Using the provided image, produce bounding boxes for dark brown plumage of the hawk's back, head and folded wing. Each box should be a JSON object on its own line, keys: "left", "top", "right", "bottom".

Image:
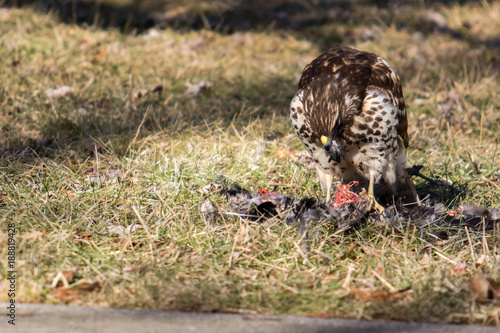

{"left": 298, "top": 47, "right": 408, "bottom": 147}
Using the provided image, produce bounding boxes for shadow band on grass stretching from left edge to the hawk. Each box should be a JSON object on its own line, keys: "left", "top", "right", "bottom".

{"left": 0, "top": 71, "right": 296, "bottom": 164}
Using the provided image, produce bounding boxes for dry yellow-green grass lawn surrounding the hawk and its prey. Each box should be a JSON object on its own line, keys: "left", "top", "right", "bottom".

{"left": 0, "top": 1, "right": 500, "bottom": 325}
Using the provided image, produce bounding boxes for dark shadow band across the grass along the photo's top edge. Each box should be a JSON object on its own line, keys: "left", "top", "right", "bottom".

{"left": 4, "top": 0, "right": 500, "bottom": 50}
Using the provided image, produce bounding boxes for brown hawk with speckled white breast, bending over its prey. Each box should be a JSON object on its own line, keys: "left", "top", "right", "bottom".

{"left": 290, "top": 47, "right": 420, "bottom": 210}
